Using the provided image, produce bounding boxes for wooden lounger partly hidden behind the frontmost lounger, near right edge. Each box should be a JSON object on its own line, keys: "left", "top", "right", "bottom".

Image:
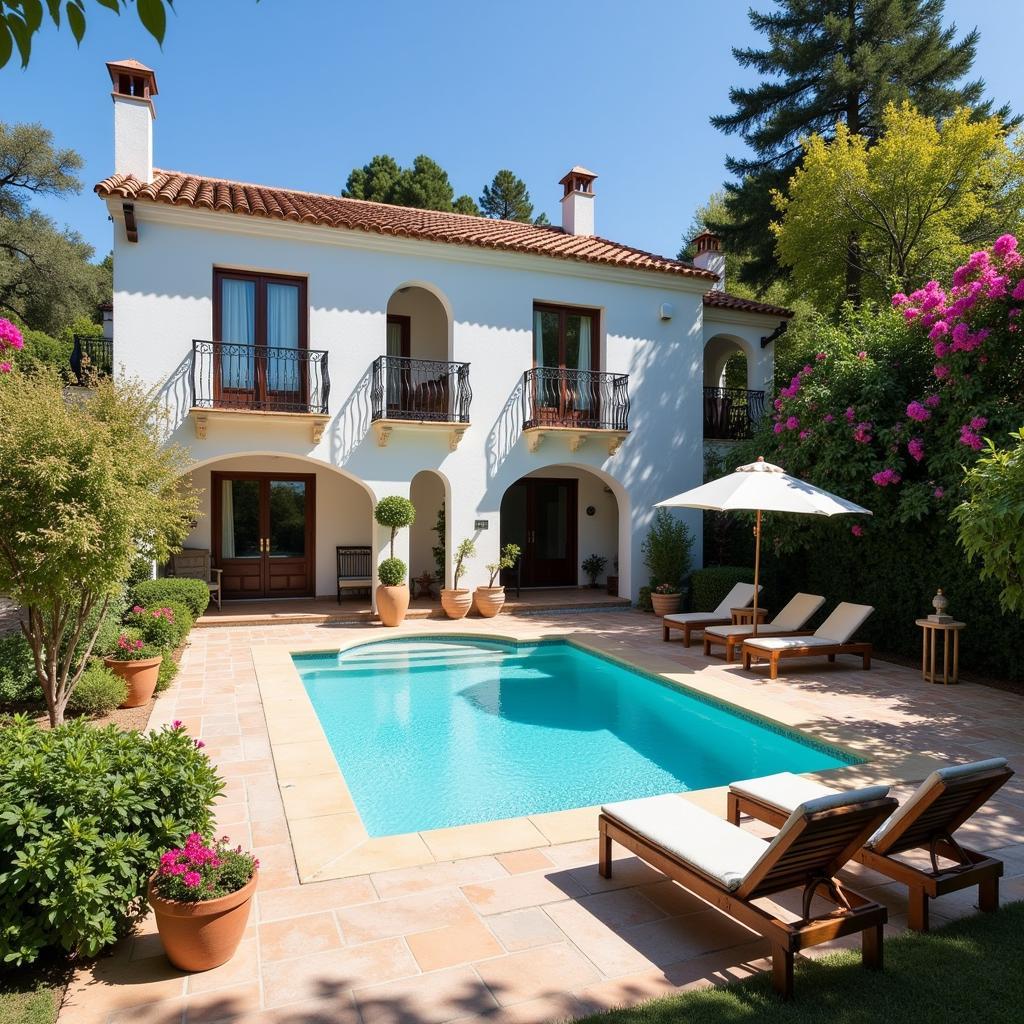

{"left": 726, "top": 758, "right": 1014, "bottom": 932}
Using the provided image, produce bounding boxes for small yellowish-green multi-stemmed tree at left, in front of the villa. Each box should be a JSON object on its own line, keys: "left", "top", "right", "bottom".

{"left": 0, "top": 368, "right": 199, "bottom": 725}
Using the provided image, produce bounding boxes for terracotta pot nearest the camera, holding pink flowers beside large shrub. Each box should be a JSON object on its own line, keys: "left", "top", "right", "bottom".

{"left": 146, "top": 869, "right": 259, "bottom": 971}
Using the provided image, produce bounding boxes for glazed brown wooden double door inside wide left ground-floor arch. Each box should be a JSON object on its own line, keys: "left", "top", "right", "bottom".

{"left": 210, "top": 472, "right": 316, "bottom": 599}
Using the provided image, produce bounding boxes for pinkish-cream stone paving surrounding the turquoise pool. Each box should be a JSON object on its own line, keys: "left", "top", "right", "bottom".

{"left": 60, "top": 611, "right": 1024, "bottom": 1024}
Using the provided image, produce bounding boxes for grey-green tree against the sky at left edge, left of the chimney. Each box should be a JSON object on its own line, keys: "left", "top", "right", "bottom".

{"left": 0, "top": 123, "right": 112, "bottom": 335}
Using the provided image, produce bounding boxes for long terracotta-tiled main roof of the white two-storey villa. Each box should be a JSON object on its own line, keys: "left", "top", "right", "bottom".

{"left": 95, "top": 170, "right": 715, "bottom": 281}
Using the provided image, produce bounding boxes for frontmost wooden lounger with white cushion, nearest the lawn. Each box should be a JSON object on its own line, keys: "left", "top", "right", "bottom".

{"left": 598, "top": 786, "right": 896, "bottom": 997}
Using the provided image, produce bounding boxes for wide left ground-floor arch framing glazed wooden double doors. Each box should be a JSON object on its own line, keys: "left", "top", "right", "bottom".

{"left": 184, "top": 453, "right": 375, "bottom": 608}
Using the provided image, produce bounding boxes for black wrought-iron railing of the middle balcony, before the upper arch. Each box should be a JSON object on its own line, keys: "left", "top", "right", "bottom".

{"left": 370, "top": 355, "right": 473, "bottom": 423}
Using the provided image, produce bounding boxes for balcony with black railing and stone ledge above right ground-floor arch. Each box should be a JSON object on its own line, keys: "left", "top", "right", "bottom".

{"left": 522, "top": 367, "right": 630, "bottom": 455}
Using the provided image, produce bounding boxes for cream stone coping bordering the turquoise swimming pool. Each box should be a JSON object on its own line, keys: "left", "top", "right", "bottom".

{"left": 251, "top": 623, "right": 944, "bottom": 883}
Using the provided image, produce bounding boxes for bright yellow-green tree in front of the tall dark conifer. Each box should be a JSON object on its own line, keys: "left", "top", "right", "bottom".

{"left": 772, "top": 103, "right": 1024, "bottom": 308}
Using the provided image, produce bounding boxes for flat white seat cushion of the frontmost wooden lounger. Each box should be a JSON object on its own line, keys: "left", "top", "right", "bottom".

{"left": 601, "top": 795, "right": 768, "bottom": 892}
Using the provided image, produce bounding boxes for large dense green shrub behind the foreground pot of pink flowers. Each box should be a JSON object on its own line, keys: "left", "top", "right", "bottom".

{"left": 0, "top": 716, "right": 223, "bottom": 968}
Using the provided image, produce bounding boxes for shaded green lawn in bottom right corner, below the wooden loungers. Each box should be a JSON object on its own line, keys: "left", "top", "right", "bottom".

{"left": 587, "top": 903, "right": 1024, "bottom": 1024}
